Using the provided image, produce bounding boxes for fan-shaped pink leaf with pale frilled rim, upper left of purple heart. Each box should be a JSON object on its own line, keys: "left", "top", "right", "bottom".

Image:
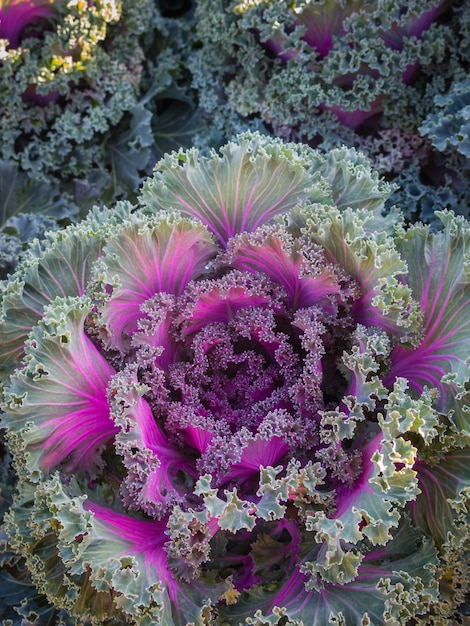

{"left": 93, "top": 215, "right": 215, "bottom": 350}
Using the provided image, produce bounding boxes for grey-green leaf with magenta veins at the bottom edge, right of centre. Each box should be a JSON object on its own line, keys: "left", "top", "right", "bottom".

{"left": 221, "top": 523, "right": 437, "bottom": 626}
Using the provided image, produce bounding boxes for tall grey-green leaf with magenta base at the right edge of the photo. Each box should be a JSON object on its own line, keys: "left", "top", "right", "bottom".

{"left": 385, "top": 213, "right": 470, "bottom": 440}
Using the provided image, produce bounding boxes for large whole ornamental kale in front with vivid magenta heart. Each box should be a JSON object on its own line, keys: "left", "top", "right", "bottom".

{"left": 0, "top": 133, "right": 470, "bottom": 626}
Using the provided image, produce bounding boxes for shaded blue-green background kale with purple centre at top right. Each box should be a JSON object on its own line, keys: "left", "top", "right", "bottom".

{"left": 189, "top": 0, "right": 470, "bottom": 223}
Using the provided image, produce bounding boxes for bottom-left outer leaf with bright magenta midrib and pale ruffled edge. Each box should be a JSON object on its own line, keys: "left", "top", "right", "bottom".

{"left": 82, "top": 502, "right": 226, "bottom": 626}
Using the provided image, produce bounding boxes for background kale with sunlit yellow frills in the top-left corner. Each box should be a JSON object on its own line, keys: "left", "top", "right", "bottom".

{"left": 0, "top": 0, "right": 202, "bottom": 212}
